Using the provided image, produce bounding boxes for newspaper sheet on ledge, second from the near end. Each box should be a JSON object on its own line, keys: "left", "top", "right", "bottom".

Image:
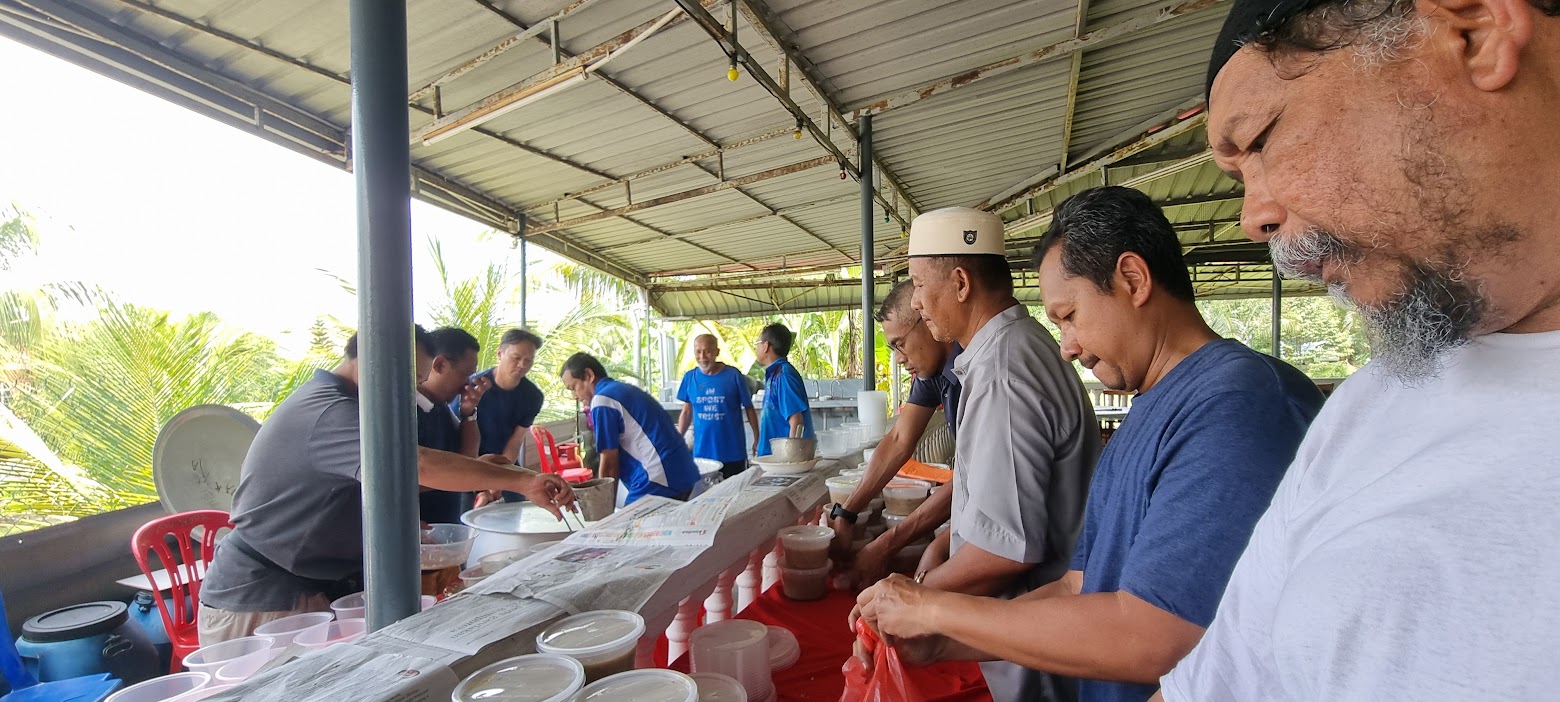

{"left": 376, "top": 583, "right": 563, "bottom": 655}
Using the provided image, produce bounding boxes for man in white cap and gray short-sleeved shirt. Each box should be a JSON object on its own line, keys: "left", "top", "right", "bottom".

{"left": 909, "top": 207, "right": 1100, "bottom": 702}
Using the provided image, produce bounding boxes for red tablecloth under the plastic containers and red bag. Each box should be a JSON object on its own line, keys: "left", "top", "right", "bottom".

{"left": 657, "top": 585, "right": 991, "bottom": 702}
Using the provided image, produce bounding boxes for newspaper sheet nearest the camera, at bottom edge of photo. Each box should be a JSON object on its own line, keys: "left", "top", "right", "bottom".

{"left": 206, "top": 644, "right": 460, "bottom": 702}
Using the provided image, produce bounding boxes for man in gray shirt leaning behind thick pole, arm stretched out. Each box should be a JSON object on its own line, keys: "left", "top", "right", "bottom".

{"left": 200, "top": 328, "right": 574, "bottom": 646}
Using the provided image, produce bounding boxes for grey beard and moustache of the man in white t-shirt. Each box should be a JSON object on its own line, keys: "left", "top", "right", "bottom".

{"left": 1328, "top": 265, "right": 1488, "bottom": 385}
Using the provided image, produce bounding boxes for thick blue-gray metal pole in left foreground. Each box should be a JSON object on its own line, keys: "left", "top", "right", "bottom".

{"left": 349, "top": 0, "right": 421, "bottom": 629}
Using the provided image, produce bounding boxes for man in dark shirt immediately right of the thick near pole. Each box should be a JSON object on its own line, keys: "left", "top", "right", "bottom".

{"left": 417, "top": 326, "right": 488, "bottom": 524}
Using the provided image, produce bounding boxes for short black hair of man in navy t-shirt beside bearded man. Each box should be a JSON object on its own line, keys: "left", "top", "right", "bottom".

{"left": 1034, "top": 186, "right": 1197, "bottom": 303}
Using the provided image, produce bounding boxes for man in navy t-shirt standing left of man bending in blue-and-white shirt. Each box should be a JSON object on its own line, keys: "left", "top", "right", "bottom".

{"left": 451, "top": 329, "right": 543, "bottom": 502}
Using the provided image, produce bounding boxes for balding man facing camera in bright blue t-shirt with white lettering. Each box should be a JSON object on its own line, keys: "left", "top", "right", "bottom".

{"left": 677, "top": 334, "right": 758, "bottom": 477}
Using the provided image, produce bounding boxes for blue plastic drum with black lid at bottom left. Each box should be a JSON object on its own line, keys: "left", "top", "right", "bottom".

{"left": 16, "top": 602, "right": 158, "bottom": 686}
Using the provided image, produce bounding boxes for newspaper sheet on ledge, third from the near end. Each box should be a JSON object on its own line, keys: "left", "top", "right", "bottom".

{"left": 466, "top": 541, "right": 705, "bottom": 615}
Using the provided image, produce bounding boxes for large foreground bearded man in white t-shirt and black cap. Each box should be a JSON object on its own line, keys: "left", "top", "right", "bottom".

{"left": 1161, "top": 0, "right": 1560, "bottom": 702}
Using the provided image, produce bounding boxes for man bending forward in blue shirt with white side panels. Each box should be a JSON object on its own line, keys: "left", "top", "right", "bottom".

{"left": 558, "top": 353, "right": 699, "bottom": 504}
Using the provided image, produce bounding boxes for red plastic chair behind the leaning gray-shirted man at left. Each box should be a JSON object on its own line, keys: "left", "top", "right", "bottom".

{"left": 129, "top": 510, "right": 232, "bottom": 672}
